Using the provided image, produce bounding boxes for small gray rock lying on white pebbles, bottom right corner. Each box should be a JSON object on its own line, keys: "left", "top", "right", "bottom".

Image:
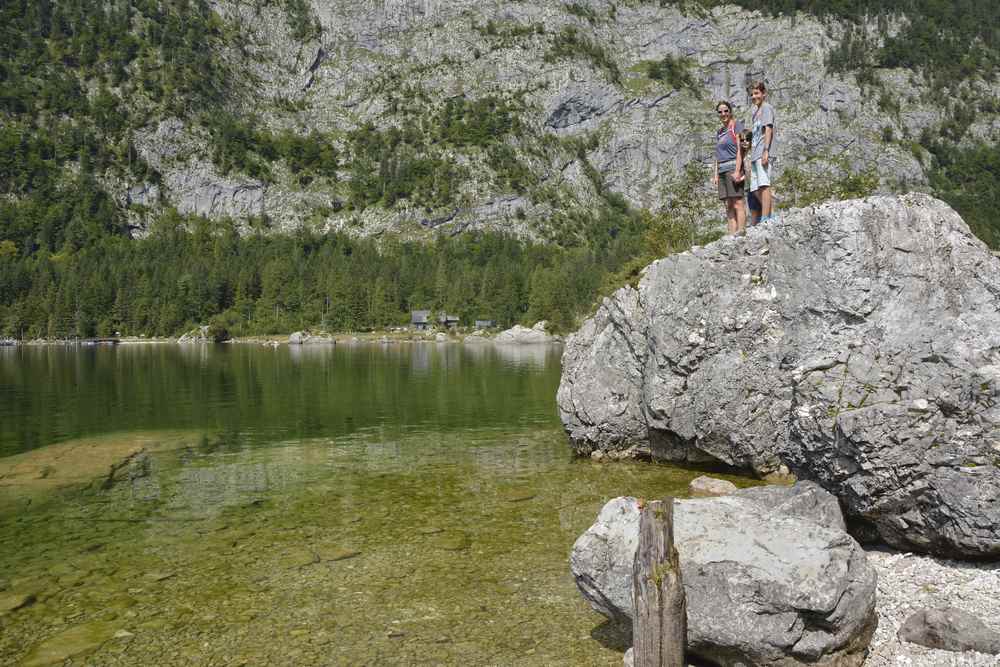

{"left": 897, "top": 607, "right": 1000, "bottom": 654}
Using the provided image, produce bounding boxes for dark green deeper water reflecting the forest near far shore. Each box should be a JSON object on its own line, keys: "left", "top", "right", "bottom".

{"left": 0, "top": 342, "right": 562, "bottom": 456}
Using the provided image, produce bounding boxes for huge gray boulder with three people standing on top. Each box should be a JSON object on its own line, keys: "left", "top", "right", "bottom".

{"left": 558, "top": 194, "right": 1000, "bottom": 558}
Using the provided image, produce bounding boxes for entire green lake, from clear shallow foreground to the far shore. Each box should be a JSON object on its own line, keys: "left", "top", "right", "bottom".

{"left": 0, "top": 344, "right": 752, "bottom": 665}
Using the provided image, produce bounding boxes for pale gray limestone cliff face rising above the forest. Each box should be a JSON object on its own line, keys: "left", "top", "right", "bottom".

{"left": 117, "top": 0, "right": 997, "bottom": 239}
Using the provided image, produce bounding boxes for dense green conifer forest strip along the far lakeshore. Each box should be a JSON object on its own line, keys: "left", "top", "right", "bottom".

{"left": 0, "top": 212, "right": 642, "bottom": 338}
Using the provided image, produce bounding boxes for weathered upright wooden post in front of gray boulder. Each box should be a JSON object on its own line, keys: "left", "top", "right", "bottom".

{"left": 632, "top": 497, "right": 687, "bottom": 667}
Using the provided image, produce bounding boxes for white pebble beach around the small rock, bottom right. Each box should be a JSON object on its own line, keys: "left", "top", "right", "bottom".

{"left": 865, "top": 550, "right": 1000, "bottom": 667}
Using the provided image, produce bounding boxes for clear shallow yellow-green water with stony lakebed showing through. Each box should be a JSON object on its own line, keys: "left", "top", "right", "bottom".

{"left": 0, "top": 428, "right": 746, "bottom": 665}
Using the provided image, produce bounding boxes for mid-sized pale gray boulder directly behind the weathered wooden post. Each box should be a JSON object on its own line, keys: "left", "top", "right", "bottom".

{"left": 570, "top": 482, "right": 876, "bottom": 666}
